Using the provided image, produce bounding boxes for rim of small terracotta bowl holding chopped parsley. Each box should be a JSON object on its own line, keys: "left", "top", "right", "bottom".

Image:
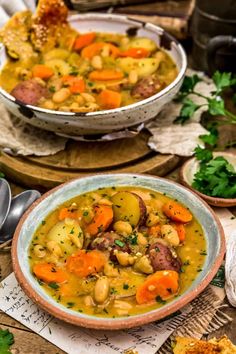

{"left": 179, "top": 151, "right": 236, "bottom": 207}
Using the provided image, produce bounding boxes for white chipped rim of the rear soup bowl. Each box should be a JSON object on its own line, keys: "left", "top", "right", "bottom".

{"left": 0, "top": 13, "right": 187, "bottom": 120}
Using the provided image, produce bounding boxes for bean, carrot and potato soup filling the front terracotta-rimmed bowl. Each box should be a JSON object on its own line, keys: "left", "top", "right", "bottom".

{"left": 28, "top": 187, "right": 206, "bottom": 317}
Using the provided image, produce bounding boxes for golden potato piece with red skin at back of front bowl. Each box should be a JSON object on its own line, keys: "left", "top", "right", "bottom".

{"left": 111, "top": 191, "right": 147, "bottom": 227}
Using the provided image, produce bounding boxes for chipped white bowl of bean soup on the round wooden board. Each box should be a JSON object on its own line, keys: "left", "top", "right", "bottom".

{"left": 0, "top": 0, "right": 187, "bottom": 136}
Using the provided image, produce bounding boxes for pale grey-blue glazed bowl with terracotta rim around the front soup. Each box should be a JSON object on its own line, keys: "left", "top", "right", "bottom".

{"left": 12, "top": 174, "right": 225, "bottom": 330}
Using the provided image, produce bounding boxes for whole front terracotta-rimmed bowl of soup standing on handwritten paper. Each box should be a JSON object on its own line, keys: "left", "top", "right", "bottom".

{"left": 12, "top": 174, "right": 225, "bottom": 330}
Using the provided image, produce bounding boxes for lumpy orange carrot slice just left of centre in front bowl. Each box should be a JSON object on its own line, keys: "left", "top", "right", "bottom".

{"left": 66, "top": 250, "right": 106, "bottom": 278}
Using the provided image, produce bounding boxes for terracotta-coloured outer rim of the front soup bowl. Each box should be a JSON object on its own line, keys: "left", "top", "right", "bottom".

{"left": 11, "top": 173, "right": 225, "bottom": 330}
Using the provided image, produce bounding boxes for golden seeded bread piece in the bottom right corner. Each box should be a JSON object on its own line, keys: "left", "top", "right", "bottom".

{"left": 173, "top": 336, "right": 236, "bottom": 354}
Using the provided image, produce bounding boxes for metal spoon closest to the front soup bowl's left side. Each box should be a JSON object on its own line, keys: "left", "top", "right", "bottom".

{"left": 0, "top": 190, "right": 41, "bottom": 243}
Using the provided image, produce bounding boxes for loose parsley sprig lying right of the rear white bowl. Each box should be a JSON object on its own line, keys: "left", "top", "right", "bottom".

{"left": 174, "top": 71, "right": 236, "bottom": 124}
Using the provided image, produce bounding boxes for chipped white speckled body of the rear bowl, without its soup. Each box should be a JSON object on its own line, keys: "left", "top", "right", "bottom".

{"left": 0, "top": 14, "right": 187, "bottom": 136}
